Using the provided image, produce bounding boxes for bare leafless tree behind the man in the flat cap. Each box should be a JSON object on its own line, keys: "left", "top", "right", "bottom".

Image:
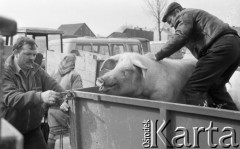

{"left": 144, "top": 0, "right": 168, "bottom": 40}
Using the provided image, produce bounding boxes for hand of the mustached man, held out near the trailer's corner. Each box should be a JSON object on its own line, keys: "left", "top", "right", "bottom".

{"left": 41, "top": 90, "right": 61, "bottom": 105}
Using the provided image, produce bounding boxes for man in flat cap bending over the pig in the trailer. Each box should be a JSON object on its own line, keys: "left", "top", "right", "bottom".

{"left": 155, "top": 2, "right": 240, "bottom": 110}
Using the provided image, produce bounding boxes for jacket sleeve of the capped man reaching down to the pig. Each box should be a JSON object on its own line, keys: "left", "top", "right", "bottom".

{"left": 155, "top": 13, "right": 193, "bottom": 60}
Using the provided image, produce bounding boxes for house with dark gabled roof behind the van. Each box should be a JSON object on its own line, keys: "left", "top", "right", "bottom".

{"left": 58, "top": 23, "right": 96, "bottom": 38}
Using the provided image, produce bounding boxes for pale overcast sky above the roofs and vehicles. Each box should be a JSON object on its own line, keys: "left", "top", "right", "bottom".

{"left": 0, "top": 0, "right": 240, "bottom": 36}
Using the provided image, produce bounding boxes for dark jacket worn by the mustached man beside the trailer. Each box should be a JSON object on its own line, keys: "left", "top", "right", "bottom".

{"left": 0, "top": 55, "right": 64, "bottom": 134}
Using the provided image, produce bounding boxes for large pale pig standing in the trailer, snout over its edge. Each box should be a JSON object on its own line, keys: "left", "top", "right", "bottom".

{"left": 96, "top": 53, "right": 240, "bottom": 109}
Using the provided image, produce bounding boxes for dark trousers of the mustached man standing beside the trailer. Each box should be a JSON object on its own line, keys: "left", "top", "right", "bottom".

{"left": 23, "top": 127, "right": 47, "bottom": 149}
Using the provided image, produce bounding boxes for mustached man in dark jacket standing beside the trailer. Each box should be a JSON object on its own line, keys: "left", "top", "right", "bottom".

{"left": 0, "top": 37, "right": 64, "bottom": 149}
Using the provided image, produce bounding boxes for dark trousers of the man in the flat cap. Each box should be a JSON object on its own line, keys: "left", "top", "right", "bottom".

{"left": 184, "top": 35, "right": 240, "bottom": 110}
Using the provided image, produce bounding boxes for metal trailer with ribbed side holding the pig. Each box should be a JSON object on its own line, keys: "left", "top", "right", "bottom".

{"left": 68, "top": 87, "right": 240, "bottom": 149}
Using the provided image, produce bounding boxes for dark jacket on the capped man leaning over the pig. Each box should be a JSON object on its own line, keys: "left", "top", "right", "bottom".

{"left": 156, "top": 8, "right": 237, "bottom": 60}
